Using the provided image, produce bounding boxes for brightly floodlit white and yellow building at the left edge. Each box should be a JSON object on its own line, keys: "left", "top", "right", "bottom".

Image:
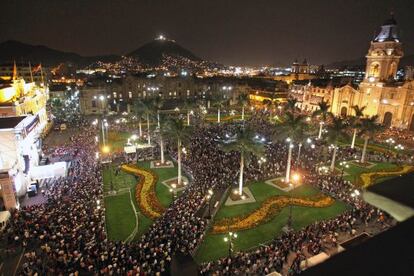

{"left": 0, "top": 65, "right": 48, "bottom": 208}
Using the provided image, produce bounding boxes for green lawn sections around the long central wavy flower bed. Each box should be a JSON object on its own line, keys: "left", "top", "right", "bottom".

{"left": 196, "top": 182, "right": 347, "bottom": 263}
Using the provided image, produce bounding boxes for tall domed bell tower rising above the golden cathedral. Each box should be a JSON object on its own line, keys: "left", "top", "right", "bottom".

{"left": 365, "top": 14, "right": 404, "bottom": 82}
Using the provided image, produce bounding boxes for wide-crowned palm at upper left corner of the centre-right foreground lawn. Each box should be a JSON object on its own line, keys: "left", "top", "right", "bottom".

{"left": 220, "top": 128, "right": 265, "bottom": 196}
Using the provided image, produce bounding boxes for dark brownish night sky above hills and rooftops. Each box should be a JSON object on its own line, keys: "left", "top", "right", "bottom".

{"left": 0, "top": 0, "right": 414, "bottom": 65}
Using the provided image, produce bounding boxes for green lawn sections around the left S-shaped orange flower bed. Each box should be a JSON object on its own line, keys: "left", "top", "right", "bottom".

{"left": 103, "top": 157, "right": 177, "bottom": 240}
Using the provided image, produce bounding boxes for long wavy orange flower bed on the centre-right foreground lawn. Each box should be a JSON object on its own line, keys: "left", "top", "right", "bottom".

{"left": 212, "top": 195, "right": 335, "bottom": 234}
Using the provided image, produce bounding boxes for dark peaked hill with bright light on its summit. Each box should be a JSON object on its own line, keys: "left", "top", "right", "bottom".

{"left": 127, "top": 39, "right": 202, "bottom": 66}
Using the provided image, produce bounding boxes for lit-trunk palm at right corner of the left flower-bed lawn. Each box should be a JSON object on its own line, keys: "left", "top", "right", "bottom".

{"left": 165, "top": 118, "right": 191, "bottom": 185}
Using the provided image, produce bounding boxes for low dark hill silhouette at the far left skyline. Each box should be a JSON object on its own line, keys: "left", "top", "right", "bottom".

{"left": 0, "top": 40, "right": 120, "bottom": 66}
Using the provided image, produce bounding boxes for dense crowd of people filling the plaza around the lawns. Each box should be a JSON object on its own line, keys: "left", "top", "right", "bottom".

{"left": 1, "top": 114, "right": 402, "bottom": 275}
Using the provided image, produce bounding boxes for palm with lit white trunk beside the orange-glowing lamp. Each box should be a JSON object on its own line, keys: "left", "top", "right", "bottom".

{"left": 275, "top": 112, "right": 308, "bottom": 183}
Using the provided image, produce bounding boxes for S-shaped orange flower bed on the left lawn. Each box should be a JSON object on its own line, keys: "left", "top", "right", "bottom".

{"left": 121, "top": 165, "right": 165, "bottom": 220}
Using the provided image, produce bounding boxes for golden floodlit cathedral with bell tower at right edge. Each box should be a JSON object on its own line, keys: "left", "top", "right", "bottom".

{"left": 292, "top": 14, "right": 414, "bottom": 131}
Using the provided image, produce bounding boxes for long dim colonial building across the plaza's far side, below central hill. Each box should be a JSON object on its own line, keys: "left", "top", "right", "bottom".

{"left": 80, "top": 75, "right": 251, "bottom": 115}
